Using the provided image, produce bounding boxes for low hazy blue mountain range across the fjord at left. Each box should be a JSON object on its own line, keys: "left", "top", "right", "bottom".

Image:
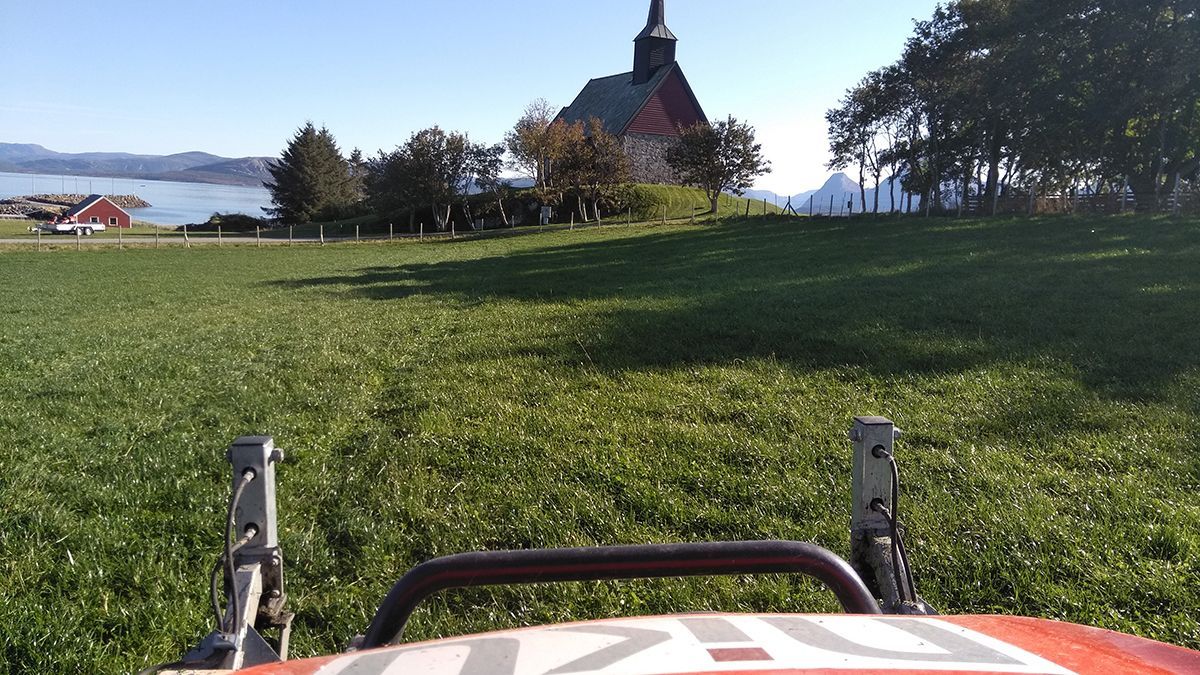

{"left": 0, "top": 143, "right": 274, "bottom": 187}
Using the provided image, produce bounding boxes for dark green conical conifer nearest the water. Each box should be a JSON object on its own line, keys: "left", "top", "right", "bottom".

{"left": 263, "top": 121, "right": 356, "bottom": 223}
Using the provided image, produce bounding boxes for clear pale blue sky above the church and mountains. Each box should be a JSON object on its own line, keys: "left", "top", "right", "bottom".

{"left": 0, "top": 0, "right": 937, "bottom": 193}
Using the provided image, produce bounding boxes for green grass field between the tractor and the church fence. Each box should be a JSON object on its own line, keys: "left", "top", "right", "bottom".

{"left": 0, "top": 213, "right": 1200, "bottom": 674}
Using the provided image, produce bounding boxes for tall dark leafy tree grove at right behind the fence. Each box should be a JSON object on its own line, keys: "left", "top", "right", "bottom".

{"left": 827, "top": 0, "right": 1200, "bottom": 209}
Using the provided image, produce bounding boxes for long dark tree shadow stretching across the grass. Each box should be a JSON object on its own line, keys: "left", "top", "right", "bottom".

{"left": 272, "top": 219, "right": 1200, "bottom": 400}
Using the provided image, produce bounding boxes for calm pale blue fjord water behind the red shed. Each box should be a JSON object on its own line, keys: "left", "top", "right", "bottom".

{"left": 0, "top": 173, "right": 271, "bottom": 225}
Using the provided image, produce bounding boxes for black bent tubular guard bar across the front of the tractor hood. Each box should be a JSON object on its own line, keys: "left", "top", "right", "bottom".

{"left": 361, "top": 542, "right": 883, "bottom": 649}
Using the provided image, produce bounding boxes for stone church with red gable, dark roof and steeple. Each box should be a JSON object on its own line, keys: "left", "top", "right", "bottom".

{"left": 557, "top": 0, "right": 708, "bottom": 183}
